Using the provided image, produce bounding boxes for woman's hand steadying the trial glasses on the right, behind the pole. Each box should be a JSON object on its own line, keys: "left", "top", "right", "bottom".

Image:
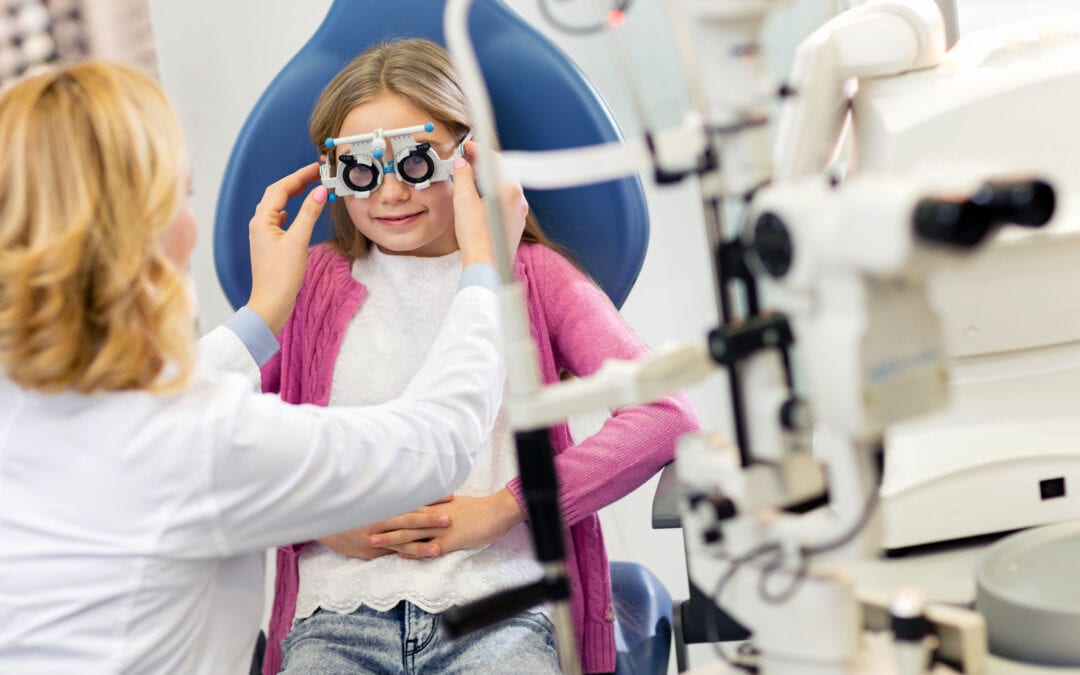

{"left": 454, "top": 140, "right": 529, "bottom": 267}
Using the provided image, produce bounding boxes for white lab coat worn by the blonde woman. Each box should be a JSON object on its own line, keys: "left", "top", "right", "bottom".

{"left": 0, "top": 286, "right": 504, "bottom": 673}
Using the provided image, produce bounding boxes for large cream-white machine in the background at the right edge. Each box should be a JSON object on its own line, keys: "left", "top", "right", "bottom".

{"left": 852, "top": 14, "right": 1080, "bottom": 549}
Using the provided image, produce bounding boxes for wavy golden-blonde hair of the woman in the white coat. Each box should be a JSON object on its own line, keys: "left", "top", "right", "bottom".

{"left": 0, "top": 62, "right": 194, "bottom": 393}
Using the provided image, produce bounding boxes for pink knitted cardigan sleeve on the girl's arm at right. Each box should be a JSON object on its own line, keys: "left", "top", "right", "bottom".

{"left": 507, "top": 246, "right": 699, "bottom": 526}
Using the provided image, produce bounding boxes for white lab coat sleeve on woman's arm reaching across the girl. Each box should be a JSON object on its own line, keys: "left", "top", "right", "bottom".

{"left": 205, "top": 286, "right": 505, "bottom": 553}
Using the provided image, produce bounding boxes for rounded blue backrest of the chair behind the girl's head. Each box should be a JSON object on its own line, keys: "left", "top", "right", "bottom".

{"left": 214, "top": 0, "right": 648, "bottom": 307}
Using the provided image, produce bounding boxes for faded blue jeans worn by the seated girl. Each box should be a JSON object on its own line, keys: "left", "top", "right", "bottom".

{"left": 282, "top": 602, "right": 559, "bottom": 675}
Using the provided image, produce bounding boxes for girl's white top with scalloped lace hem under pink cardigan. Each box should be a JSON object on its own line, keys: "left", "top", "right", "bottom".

{"left": 296, "top": 246, "right": 542, "bottom": 619}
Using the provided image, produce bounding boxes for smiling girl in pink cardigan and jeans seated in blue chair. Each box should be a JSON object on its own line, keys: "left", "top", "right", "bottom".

{"left": 264, "top": 39, "right": 697, "bottom": 674}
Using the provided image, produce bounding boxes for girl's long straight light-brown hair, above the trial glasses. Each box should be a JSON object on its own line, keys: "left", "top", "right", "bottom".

{"left": 308, "top": 38, "right": 558, "bottom": 257}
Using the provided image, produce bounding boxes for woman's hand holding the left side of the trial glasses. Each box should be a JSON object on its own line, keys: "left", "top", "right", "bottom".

{"left": 247, "top": 162, "right": 326, "bottom": 335}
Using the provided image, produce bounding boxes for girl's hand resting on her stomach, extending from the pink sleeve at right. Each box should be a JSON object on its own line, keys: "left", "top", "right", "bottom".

{"left": 368, "top": 488, "right": 525, "bottom": 559}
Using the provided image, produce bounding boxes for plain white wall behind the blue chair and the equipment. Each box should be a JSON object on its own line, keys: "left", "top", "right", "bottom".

{"left": 150, "top": 0, "right": 1072, "bottom": 667}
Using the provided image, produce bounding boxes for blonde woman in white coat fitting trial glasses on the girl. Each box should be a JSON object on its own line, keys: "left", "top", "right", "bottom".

{"left": 0, "top": 63, "right": 521, "bottom": 673}
